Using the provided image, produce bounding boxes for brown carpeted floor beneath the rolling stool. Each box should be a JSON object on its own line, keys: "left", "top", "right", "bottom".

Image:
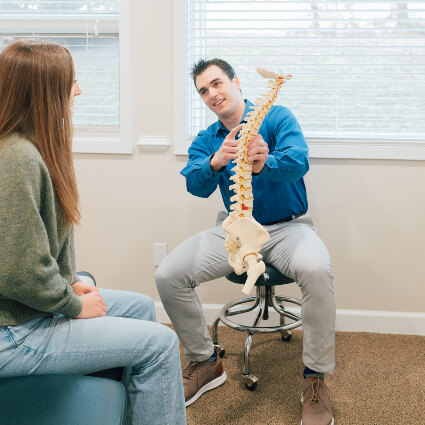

{"left": 182, "top": 326, "right": 425, "bottom": 425}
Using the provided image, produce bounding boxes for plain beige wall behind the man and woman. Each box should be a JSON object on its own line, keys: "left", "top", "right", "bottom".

{"left": 75, "top": 0, "right": 425, "bottom": 312}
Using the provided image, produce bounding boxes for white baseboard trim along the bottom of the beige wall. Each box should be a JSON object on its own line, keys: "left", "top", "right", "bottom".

{"left": 155, "top": 301, "right": 425, "bottom": 336}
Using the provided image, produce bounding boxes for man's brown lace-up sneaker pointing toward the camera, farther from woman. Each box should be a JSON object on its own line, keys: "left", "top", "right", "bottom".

{"left": 301, "top": 376, "right": 334, "bottom": 425}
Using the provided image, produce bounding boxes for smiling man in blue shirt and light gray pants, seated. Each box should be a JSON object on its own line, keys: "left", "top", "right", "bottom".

{"left": 155, "top": 59, "right": 335, "bottom": 425}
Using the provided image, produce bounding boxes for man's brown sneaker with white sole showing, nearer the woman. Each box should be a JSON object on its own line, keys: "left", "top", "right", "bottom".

{"left": 183, "top": 355, "right": 227, "bottom": 407}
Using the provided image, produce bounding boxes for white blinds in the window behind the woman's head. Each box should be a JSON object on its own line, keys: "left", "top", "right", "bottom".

{"left": 0, "top": 0, "right": 120, "bottom": 131}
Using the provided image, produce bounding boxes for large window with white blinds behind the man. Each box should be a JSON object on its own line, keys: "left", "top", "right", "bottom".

{"left": 175, "top": 0, "right": 425, "bottom": 159}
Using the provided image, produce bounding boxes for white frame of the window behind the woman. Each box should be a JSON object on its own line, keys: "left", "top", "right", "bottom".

{"left": 0, "top": 0, "right": 133, "bottom": 154}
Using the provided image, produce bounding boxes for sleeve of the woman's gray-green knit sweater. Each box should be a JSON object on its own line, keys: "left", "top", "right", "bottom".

{"left": 0, "top": 144, "right": 82, "bottom": 317}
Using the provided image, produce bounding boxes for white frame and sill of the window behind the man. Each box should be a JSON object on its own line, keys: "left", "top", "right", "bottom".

{"left": 173, "top": 0, "right": 425, "bottom": 160}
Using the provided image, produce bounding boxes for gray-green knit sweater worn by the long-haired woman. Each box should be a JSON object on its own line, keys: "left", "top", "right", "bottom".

{"left": 0, "top": 135, "right": 82, "bottom": 326}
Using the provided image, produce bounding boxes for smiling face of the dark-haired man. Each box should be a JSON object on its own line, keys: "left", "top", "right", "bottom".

{"left": 196, "top": 65, "right": 244, "bottom": 119}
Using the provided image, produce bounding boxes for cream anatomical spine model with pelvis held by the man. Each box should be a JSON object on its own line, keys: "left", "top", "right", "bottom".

{"left": 222, "top": 68, "right": 292, "bottom": 294}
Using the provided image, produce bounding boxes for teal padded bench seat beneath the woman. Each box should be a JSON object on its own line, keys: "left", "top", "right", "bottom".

{"left": 0, "top": 375, "right": 126, "bottom": 425}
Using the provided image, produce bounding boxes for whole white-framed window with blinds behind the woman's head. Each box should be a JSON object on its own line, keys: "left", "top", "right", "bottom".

{"left": 0, "top": 0, "right": 132, "bottom": 153}
